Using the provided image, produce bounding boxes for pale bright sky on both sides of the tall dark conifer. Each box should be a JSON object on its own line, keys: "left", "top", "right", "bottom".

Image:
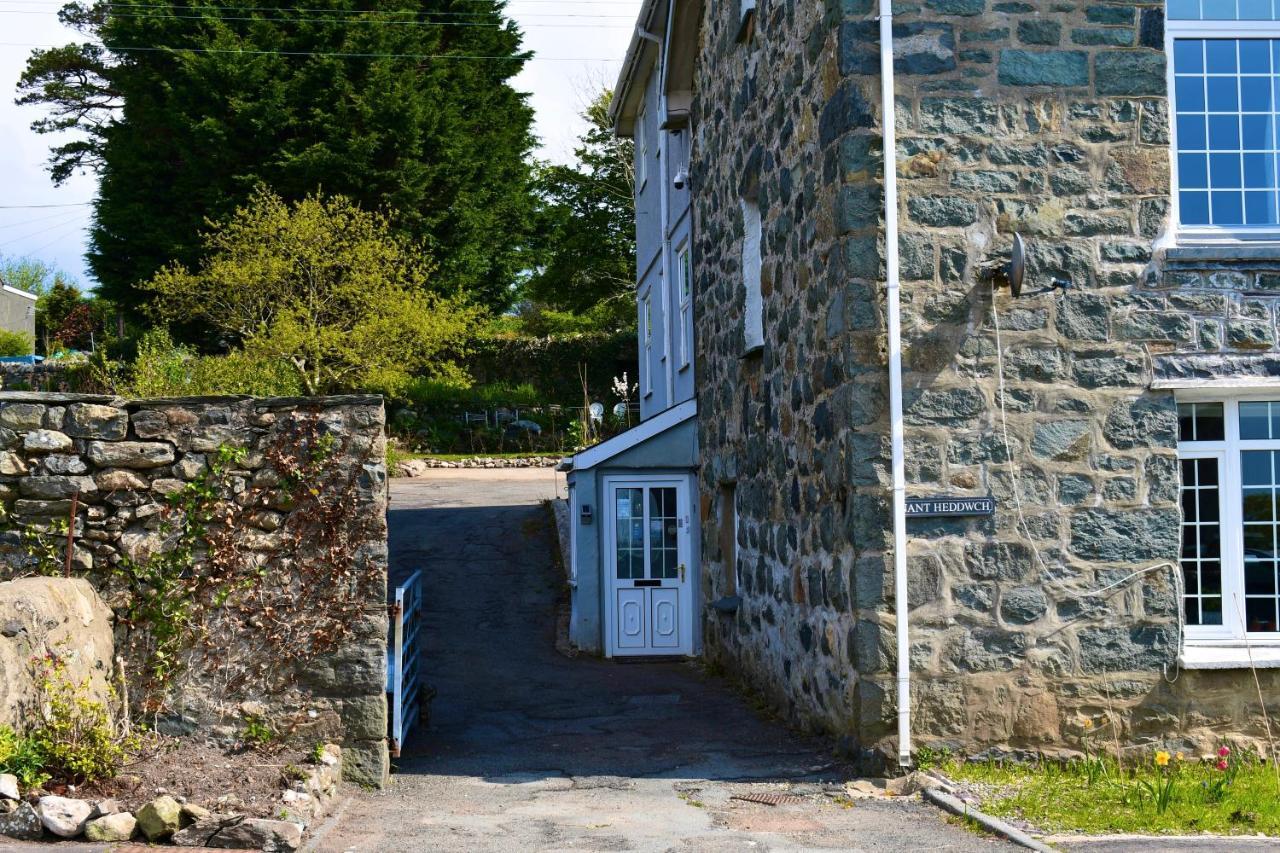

{"left": 0, "top": 0, "right": 641, "bottom": 287}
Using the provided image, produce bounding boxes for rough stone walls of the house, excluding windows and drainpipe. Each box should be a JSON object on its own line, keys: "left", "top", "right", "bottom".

{"left": 692, "top": 0, "right": 1280, "bottom": 754}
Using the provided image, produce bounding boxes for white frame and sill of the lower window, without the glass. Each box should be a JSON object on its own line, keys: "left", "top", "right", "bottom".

{"left": 1176, "top": 388, "right": 1280, "bottom": 669}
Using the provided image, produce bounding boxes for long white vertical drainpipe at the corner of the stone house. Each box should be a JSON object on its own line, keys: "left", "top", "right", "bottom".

{"left": 879, "top": 0, "right": 911, "bottom": 767}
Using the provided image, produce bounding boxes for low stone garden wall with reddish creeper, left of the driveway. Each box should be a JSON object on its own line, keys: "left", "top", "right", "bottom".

{"left": 0, "top": 393, "right": 388, "bottom": 784}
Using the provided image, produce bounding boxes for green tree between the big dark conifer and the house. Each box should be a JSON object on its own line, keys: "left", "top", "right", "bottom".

{"left": 525, "top": 90, "right": 636, "bottom": 329}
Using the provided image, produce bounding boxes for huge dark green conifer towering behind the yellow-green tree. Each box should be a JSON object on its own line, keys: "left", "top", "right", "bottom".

{"left": 19, "top": 0, "right": 532, "bottom": 324}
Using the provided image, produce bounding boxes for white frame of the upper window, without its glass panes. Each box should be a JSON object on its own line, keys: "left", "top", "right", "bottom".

{"left": 1165, "top": 20, "right": 1280, "bottom": 246}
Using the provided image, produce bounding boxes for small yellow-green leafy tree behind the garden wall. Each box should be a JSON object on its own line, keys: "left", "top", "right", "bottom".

{"left": 143, "top": 190, "right": 481, "bottom": 394}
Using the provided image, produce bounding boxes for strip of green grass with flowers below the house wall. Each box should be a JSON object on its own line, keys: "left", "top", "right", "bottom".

{"left": 938, "top": 754, "right": 1280, "bottom": 835}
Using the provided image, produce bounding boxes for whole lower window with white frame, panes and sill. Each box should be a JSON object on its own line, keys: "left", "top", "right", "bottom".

{"left": 1178, "top": 389, "right": 1280, "bottom": 669}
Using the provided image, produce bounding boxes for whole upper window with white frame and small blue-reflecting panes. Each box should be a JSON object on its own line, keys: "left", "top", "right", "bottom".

{"left": 1165, "top": 14, "right": 1280, "bottom": 246}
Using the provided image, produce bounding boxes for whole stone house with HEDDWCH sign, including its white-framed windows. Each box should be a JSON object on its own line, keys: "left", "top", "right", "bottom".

{"left": 601, "top": 0, "right": 1280, "bottom": 762}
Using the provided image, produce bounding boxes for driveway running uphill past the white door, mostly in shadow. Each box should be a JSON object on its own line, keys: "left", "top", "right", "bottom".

{"left": 314, "top": 470, "right": 1012, "bottom": 853}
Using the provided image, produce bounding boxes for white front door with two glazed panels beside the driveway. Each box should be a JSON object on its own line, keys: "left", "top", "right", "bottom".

{"left": 605, "top": 479, "right": 694, "bottom": 657}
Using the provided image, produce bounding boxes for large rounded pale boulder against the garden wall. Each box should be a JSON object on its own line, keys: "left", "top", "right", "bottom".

{"left": 0, "top": 578, "right": 115, "bottom": 727}
